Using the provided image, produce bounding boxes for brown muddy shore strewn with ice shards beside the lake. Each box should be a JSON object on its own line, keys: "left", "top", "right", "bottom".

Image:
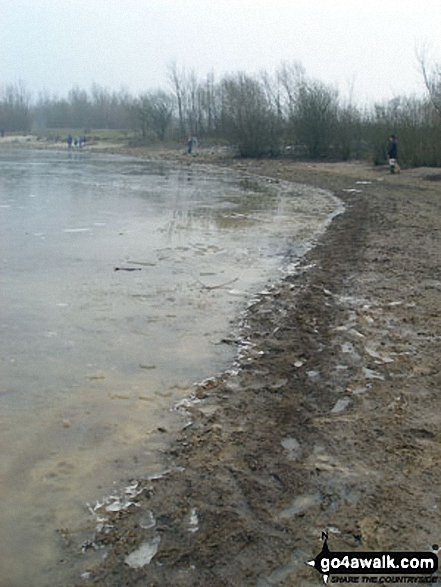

{"left": 15, "top": 149, "right": 441, "bottom": 587}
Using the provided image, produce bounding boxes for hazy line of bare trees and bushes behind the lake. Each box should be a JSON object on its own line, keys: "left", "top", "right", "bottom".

{"left": 0, "top": 59, "right": 441, "bottom": 167}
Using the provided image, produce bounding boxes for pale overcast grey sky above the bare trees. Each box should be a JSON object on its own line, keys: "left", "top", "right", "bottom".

{"left": 0, "top": 0, "right": 441, "bottom": 103}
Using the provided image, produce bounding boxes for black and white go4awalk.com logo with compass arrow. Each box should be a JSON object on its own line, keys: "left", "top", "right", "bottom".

{"left": 306, "top": 532, "right": 438, "bottom": 585}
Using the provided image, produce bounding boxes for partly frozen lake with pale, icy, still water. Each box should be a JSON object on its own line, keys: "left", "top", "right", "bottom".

{"left": 0, "top": 151, "right": 337, "bottom": 587}
